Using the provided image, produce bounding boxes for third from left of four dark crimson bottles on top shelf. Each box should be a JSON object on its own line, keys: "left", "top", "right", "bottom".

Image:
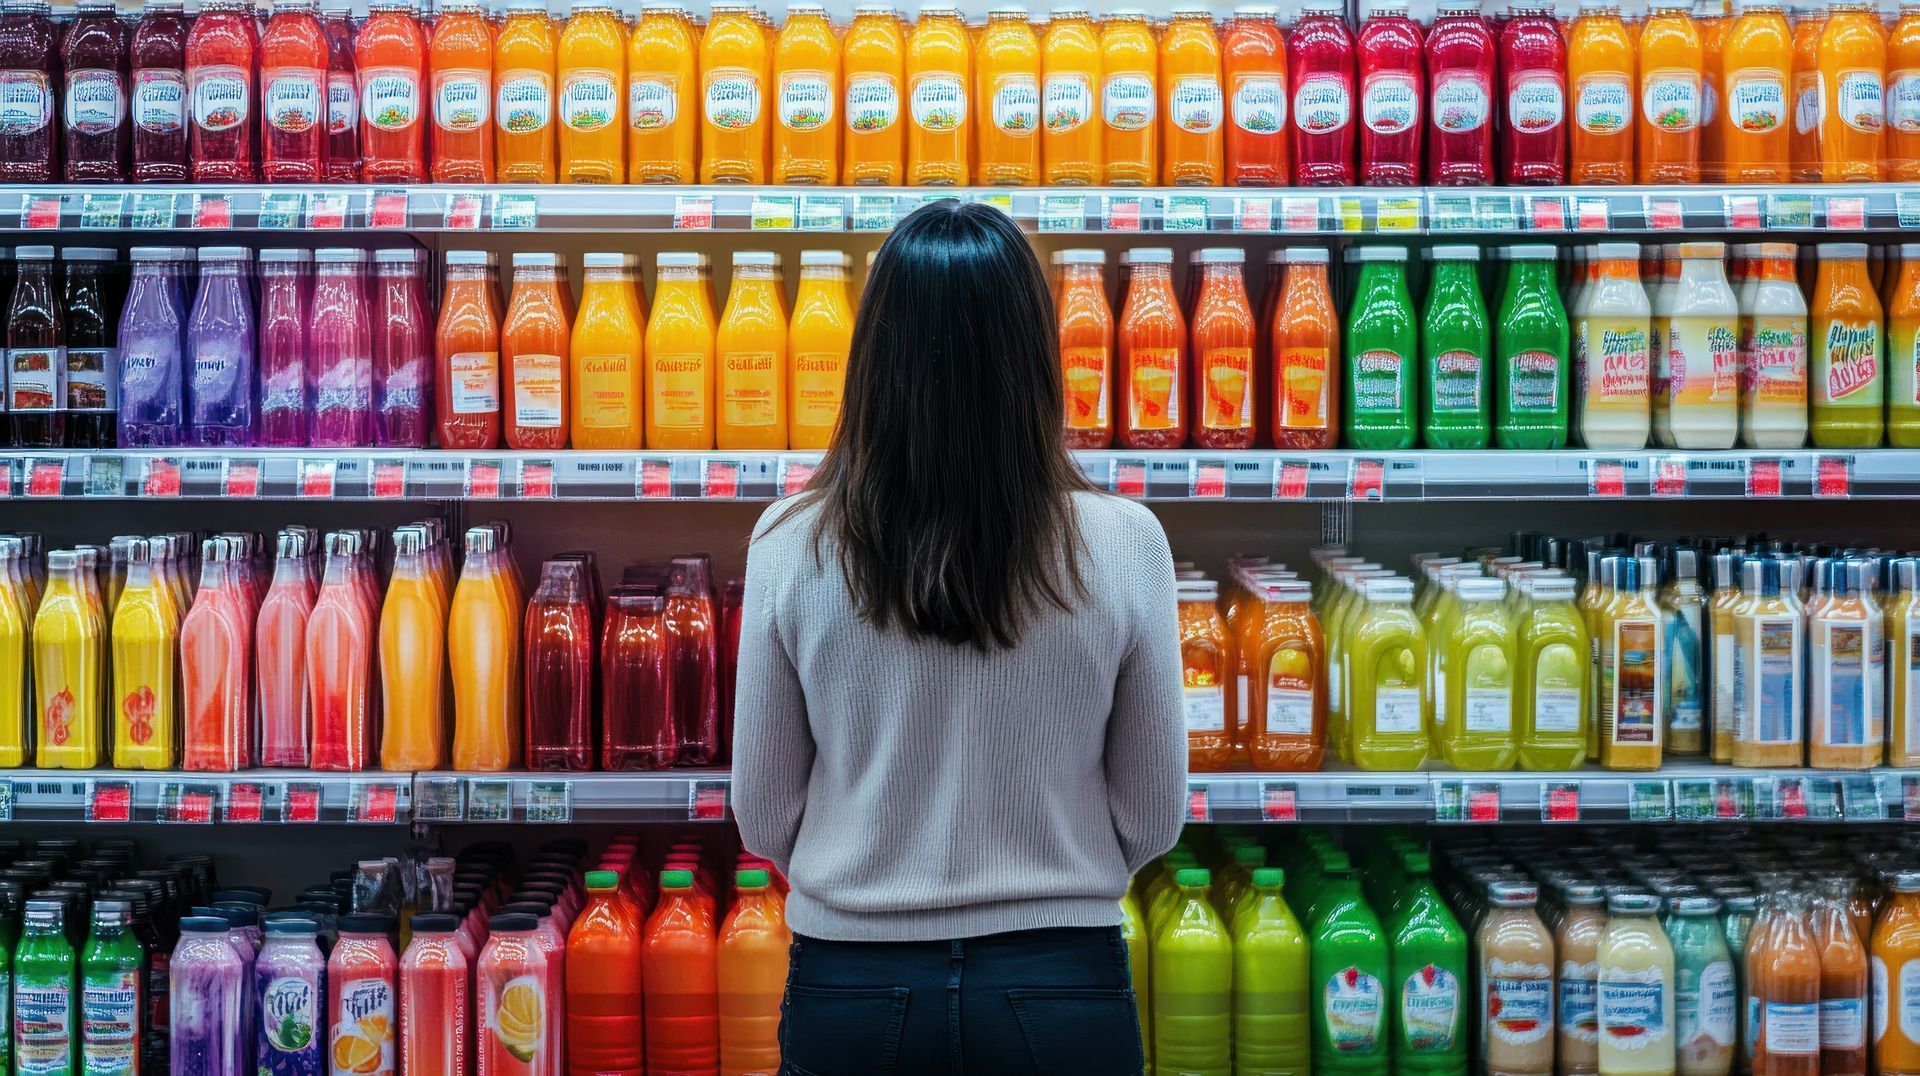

{"left": 1427, "top": 0, "right": 1498, "bottom": 186}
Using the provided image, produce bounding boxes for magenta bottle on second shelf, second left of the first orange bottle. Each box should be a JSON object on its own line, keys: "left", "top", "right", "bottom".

{"left": 307, "top": 248, "right": 372, "bottom": 448}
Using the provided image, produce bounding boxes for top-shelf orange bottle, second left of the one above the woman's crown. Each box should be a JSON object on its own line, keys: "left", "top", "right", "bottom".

{"left": 774, "top": 4, "right": 841, "bottom": 184}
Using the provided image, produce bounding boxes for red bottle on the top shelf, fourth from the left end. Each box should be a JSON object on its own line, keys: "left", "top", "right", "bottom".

{"left": 186, "top": 0, "right": 259, "bottom": 183}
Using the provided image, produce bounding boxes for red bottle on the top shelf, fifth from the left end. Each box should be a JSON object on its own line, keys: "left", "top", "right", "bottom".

{"left": 259, "top": 0, "right": 326, "bottom": 183}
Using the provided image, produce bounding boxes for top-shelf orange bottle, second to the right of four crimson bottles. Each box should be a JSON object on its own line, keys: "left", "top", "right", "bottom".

{"left": 1638, "top": 0, "right": 1705, "bottom": 183}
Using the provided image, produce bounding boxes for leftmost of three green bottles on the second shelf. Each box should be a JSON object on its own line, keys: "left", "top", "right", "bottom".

{"left": 1346, "top": 246, "right": 1419, "bottom": 450}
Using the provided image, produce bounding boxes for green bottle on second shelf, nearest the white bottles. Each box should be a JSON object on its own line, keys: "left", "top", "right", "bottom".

{"left": 1494, "top": 244, "right": 1571, "bottom": 450}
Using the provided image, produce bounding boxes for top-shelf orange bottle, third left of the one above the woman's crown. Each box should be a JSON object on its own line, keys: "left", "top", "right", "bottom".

{"left": 701, "top": 4, "right": 774, "bottom": 183}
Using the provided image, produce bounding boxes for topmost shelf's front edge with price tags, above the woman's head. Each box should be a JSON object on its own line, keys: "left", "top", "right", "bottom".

{"left": 15, "top": 184, "right": 1920, "bottom": 238}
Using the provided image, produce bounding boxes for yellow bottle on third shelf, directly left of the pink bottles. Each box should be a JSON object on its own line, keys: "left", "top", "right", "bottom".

{"left": 109, "top": 540, "right": 180, "bottom": 770}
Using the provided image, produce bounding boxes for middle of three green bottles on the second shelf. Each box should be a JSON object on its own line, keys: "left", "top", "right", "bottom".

{"left": 1421, "top": 246, "right": 1494, "bottom": 448}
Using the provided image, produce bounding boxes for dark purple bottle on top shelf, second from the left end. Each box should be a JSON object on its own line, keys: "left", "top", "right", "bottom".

{"left": 60, "top": 0, "right": 129, "bottom": 183}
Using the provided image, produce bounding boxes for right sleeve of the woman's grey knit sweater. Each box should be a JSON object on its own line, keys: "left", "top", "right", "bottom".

{"left": 1106, "top": 505, "right": 1187, "bottom": 874}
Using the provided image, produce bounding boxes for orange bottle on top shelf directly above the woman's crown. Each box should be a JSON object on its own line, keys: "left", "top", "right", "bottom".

{"left": 906, "top": 4, "right": 973, "bottom": 186}
